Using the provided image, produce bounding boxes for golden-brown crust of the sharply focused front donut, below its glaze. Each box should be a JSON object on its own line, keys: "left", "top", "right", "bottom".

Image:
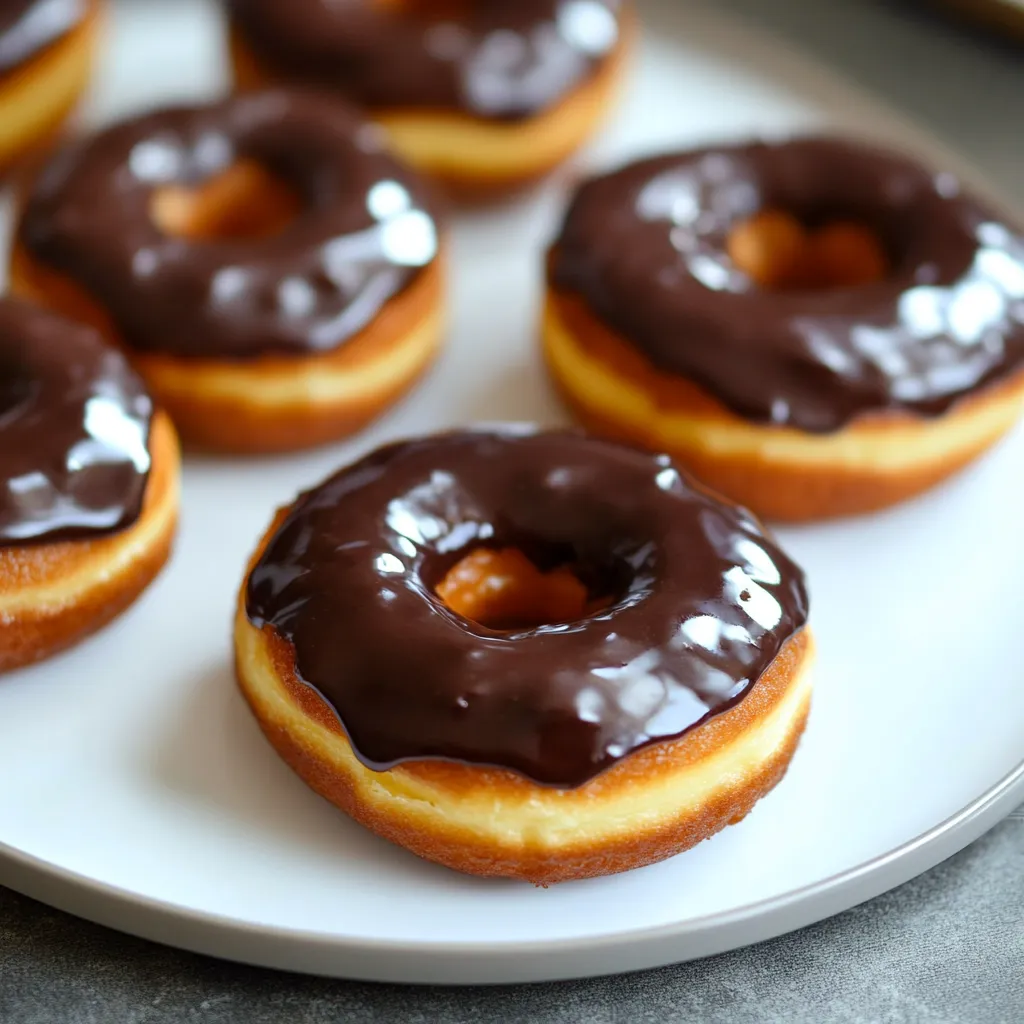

{"left": 234, "top": 511, "right": 813, "bottom": 886}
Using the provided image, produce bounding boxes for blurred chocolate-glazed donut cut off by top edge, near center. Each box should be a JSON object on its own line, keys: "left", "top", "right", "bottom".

{"left": 227, "top": 0, "right": 634, "bottom": 198}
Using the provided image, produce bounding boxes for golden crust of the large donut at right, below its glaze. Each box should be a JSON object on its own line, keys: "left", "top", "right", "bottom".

{"left": 542, "top": 288, "right": 1024, "bottom": 522}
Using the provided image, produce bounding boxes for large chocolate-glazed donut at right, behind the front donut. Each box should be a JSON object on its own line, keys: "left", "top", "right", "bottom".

{"left": 542, "top": 137, "right": 1024, "bottom": 521}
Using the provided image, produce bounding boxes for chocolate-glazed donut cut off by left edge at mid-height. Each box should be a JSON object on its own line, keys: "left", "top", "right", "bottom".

{"left": 0, "top": 299, "right": 178, "bottom": 671}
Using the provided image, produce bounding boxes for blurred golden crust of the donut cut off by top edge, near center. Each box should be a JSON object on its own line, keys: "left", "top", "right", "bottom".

{"left": 229, "top": 10, "right": 638, "bottom": 201}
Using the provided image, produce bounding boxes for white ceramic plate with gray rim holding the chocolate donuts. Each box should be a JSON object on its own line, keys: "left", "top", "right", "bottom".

{"left": 0, "top": 0, "right": 1024, "bottom": 982}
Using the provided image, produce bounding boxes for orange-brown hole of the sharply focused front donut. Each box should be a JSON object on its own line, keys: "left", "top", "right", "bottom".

{"left": 434, "top": 548, "right": 612, "bottom": 630}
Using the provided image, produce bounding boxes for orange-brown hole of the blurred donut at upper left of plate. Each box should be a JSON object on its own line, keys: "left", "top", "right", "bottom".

{"left": 150, "top": 160, "right": 301, "bottom": 242}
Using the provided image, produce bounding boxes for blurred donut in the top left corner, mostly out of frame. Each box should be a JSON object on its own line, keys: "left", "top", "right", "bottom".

{"left": 0, "top": 0, "right": 101, "bottom": 171}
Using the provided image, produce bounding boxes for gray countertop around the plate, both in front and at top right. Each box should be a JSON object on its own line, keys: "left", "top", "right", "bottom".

{"left": 6, "top": 0, "right": 1024, "bottom": 1024}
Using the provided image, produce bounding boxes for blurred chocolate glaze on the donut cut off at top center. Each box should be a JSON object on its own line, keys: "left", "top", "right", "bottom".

{"left": 228, "top": 0, "right": 628, "bottom": 119}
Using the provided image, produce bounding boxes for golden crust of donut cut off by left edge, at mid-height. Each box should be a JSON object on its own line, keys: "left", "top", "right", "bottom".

{"left": 0, "top": 412, "right": 179, "bottom": 672}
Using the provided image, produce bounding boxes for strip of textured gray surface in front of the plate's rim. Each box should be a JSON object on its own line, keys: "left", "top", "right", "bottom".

{"left": 0, "top": 817, "right": 1024, "bottom": 1024}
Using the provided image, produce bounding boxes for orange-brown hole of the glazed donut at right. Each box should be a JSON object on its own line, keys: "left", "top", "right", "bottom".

{"left": 726, "top": 209, "right": 890, "bottom": 291}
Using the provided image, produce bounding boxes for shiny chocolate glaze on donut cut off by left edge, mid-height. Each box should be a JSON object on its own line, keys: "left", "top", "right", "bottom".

{"left": 0, "top": 299, "right": 153, "bottom": 548}
